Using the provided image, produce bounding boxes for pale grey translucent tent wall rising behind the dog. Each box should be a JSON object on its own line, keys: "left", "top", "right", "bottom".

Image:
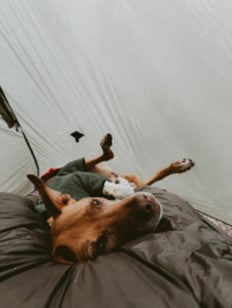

{"left": 0, "top": 0, "right": 232, "bottom": 223}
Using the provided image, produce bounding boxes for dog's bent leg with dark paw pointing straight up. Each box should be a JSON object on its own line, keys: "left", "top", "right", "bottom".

{"left": 85, "top": 134, "right": 114, "bottom": 173}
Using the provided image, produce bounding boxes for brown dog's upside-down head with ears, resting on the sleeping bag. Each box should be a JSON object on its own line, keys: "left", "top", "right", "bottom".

{"left": 28, "top": 175, "right": 162, "bottom": 263}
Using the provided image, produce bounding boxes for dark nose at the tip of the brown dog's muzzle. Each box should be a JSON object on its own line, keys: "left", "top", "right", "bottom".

{"left": 134, "top": 192, "right": 159, "bottom": 217}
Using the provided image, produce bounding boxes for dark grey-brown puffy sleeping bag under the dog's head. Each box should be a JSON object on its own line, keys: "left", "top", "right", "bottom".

{"left": 0, "top": 187, "right": 232, "bottom": 308}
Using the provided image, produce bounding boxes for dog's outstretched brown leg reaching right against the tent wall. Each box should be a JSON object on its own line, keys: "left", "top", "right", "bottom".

{"left": 145, "top": 158, "right": 195, "bottom": 185}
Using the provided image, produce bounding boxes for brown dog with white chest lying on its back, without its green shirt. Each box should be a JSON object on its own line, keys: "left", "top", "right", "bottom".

{"left": 28, "top": 134, "right": 194, "bottom": 264}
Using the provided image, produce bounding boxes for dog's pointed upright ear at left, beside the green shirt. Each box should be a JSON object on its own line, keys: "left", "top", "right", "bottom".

{"left": 27, "top": 174, "right": 74, "bottom": 217}
